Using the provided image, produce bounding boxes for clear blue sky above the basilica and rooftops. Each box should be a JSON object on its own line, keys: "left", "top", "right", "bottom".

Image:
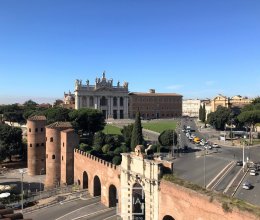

{"left": 0, "top": 0, "right": 260, "bottom": 103}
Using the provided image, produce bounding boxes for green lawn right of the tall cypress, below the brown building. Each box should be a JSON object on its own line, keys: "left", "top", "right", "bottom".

{"left": 142, "top": 121, "right": 177, "bottom": 133}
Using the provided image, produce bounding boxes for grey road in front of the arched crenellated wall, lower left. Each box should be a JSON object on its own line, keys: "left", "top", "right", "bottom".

{"left": 24, "top": 197, "right": 116, "bottom": 220}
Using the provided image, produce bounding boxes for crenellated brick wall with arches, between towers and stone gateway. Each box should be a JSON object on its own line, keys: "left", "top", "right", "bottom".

{"left": 74, "top": 149, "right": 120, "bottom": 206}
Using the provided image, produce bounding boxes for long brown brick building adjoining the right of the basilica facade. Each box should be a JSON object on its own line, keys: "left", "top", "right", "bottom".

{"left": 129, "top": 89, "right": 182, "bottom": 119}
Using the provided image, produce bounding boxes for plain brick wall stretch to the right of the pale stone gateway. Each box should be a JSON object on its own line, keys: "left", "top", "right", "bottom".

{"left": 159, "top": 180, "right": 259, "bottom": 220}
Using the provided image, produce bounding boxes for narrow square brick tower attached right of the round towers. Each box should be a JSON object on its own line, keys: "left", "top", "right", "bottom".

{"left": 60, "top": 129, "right": 79, "bottom": 185}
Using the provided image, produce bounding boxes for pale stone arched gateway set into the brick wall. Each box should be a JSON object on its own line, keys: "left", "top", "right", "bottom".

{"left": 120, "top": 145, "right": 172, "bottom": 220}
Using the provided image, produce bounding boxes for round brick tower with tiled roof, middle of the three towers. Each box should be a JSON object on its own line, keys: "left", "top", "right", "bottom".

{"left": 45, "top": 122, "right": 73, "bottom": 188}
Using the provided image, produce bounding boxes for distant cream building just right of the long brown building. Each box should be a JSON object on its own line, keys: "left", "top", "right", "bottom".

{"left": 182, "top": 99, "right": 201, "bottom": 117}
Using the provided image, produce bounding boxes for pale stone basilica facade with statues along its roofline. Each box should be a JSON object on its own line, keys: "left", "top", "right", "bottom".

{"left": 75, "top": 72, "right": 128, "bottom": 119}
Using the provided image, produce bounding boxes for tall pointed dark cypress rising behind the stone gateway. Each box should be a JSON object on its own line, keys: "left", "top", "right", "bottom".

{"left": 131, "top": 112, "right": 143, "bottom": 151}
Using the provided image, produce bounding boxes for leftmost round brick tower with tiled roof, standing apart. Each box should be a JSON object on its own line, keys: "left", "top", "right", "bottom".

{"left": 27, "top": 115, "right": 46, "bottom": 176}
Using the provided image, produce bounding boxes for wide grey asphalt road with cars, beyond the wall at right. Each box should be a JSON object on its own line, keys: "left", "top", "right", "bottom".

{"left": 178, "top": 119, "right": 260, "bottom": 205}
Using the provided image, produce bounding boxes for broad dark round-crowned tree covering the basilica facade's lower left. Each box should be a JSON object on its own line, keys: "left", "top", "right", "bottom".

{"left": 69, "top": 108, "right": 105, "bottom": 135}
